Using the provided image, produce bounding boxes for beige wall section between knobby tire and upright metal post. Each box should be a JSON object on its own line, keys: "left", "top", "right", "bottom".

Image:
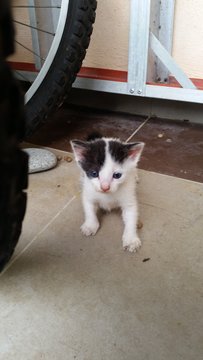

{"left": 83, "top": 0, "right": 130, "bottom": 70}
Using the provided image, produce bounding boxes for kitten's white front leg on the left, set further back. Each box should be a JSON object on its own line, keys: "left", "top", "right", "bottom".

{"left": 81, "top": 197, "right": 99, "bottom": 236}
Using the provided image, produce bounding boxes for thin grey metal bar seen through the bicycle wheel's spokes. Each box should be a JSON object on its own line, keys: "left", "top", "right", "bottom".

{"left": 28, "top": 0, "right": 42, "bottom": 70}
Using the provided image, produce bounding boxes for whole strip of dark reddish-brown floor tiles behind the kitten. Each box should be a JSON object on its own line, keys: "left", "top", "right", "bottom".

{"left": 27, "top": 104, "right": 203, "bottom": 182}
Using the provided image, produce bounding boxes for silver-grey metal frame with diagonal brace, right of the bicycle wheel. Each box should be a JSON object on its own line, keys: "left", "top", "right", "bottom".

{"left": 73, "top": 0, "right": 203, "bottom": 103}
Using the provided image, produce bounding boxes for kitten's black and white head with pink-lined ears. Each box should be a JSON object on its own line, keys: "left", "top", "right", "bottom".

{"left": 71, "top": 137, "right": 144, "bottom": 193}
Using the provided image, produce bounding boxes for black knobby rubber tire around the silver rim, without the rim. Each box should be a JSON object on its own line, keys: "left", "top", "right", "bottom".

{"left": 25, "top": 0, "right": 97, "bottom": 137}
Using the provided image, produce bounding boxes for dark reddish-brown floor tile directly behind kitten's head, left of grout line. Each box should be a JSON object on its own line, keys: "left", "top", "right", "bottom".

{"left": 27, "top": 105, "right": 143, "bottom": 151}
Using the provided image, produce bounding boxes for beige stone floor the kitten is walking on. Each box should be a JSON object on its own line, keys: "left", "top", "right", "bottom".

{"left": 0, "top": 148, "right": 203, "bottom": 360}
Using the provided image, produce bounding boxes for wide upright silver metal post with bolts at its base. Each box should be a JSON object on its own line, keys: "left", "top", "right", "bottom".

{"left": 128, "top": 0, "right": 150, "bottom": 95}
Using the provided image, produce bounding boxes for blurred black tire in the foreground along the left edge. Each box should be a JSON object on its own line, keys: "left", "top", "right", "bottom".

{"left": 0, "top": 0, "right": 28, "bottom": 271}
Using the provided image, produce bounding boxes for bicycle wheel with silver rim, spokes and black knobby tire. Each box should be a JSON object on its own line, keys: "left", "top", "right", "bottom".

{"left": 14, "top": 0, "right": 97, "bottom": 136}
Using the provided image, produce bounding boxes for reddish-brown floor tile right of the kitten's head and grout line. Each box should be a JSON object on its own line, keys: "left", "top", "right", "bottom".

{"left": 133, "top": 119, "right": 203, "bottom": 182}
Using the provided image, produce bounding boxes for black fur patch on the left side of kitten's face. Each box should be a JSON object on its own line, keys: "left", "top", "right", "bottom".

{"left": 80, "top": 139, "right": 106, "bottom": 177}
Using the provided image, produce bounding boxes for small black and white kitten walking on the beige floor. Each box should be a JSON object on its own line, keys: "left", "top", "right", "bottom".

{"left": 71, "top": 137, "right": 144, "bottom": 252}
